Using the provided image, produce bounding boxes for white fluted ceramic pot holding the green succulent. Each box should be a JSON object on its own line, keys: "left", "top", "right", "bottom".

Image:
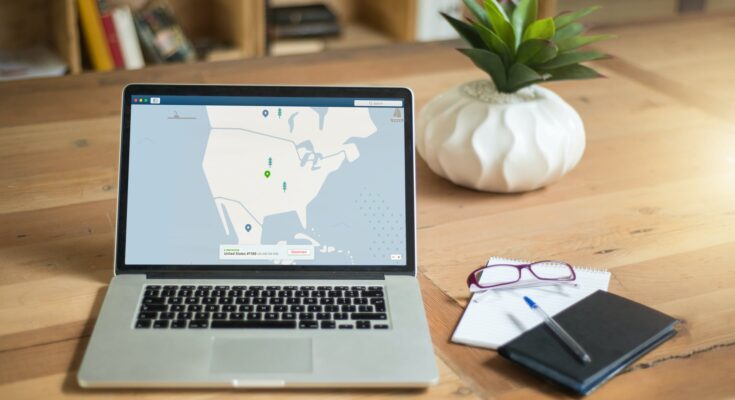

{"left": 416, "top": 80, "right": 585, "bottom": 193}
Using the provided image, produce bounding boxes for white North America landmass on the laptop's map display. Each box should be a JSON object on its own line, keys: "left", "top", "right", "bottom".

{"left": 202, "top": 106, "right": 377, "bottom": 245}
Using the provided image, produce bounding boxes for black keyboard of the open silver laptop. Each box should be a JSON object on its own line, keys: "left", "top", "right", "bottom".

{"left": 134, "top": 285, "right": 389, "bottom": 329}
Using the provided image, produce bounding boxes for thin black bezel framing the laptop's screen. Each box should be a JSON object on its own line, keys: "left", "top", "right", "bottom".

{"left": 115, "top": 84, "right": 416, "bottom": 277}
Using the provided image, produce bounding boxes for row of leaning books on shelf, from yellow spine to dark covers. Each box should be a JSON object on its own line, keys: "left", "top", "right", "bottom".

{"left": 78, "top": 0, "right": 195, "bottom": 71}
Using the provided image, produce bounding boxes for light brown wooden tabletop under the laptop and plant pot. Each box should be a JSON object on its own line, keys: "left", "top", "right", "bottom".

{"left": 0, "top": 15, "right": 735, "bottom": 399}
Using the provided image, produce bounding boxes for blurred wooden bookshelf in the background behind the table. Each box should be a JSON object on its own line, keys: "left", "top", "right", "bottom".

{"left": 0, "top": 0, "right": 735, "bottom": 78}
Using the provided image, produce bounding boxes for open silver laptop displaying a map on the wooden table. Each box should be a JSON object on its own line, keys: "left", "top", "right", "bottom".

{"left": 78, "top": 84, "right": 438, "bottom": 388}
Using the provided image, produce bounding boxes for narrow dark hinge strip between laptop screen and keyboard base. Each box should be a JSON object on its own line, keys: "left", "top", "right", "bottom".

{"left": 146, "top": 271, "right": 385, "bottom": 280}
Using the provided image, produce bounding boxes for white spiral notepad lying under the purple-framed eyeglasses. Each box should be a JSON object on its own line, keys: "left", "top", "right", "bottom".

{"left": 452, "top": 257, "right": 610, "bottom": 349}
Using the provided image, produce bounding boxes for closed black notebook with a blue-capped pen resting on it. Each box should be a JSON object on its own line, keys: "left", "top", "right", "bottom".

{"left": 498, "top": 290, "right": 677, "bottom": 394}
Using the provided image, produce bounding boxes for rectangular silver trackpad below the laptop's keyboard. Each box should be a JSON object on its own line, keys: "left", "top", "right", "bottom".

{"left": 210, "top": 338, "right": 312, "bottom": 374}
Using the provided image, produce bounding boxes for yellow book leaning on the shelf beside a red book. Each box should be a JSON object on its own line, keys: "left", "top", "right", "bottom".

{"left": 77, "top": 0, "right": 115, "bottom": 71}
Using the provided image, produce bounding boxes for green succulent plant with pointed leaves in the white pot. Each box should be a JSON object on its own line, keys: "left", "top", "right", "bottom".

{"left": 442, "top": 0, "right": 613, "bottom": 93}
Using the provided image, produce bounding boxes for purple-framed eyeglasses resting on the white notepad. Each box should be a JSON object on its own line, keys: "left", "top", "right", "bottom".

{"left": 467, "top": 260, "right": 577, "bottom": 290}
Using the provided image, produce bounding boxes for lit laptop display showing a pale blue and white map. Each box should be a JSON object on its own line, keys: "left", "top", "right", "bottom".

{"left": 124, "top": 95, "right": 412, "bottom": 266}
